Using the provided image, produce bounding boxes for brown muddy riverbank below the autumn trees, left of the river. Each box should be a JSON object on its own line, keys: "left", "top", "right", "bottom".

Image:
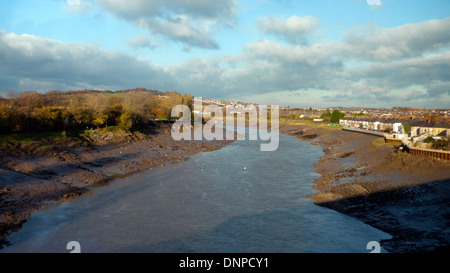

{"left": 0, "top": 122, "right": 236, "bottom": 248}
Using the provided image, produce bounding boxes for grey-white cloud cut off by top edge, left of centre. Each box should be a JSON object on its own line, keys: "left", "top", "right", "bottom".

{"left": 93, "top": 0, "right": 237, "bottom": 49}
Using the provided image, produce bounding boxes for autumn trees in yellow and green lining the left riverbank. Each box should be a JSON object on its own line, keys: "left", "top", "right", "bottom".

{"left": 0, "top": 89, "right": 192, "bottom": 134}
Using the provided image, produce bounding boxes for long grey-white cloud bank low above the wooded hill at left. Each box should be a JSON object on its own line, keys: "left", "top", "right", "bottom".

{"left": 0, "top": 31, "right": 167, "bottom": 91}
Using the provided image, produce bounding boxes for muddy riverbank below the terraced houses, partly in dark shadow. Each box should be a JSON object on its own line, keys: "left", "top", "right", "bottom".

{"left": 280, "top": 123, "right": 450, "bottom": 252}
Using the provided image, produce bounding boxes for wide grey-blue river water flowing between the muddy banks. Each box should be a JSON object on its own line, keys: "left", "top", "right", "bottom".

{"left": 1, "top": 131, "right": 391, "bottom": 253}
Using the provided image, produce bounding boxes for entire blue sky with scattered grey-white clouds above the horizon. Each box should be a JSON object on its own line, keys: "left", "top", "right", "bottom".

{"left": 0, "top": 0, "right": 450, "bottom": 109}
